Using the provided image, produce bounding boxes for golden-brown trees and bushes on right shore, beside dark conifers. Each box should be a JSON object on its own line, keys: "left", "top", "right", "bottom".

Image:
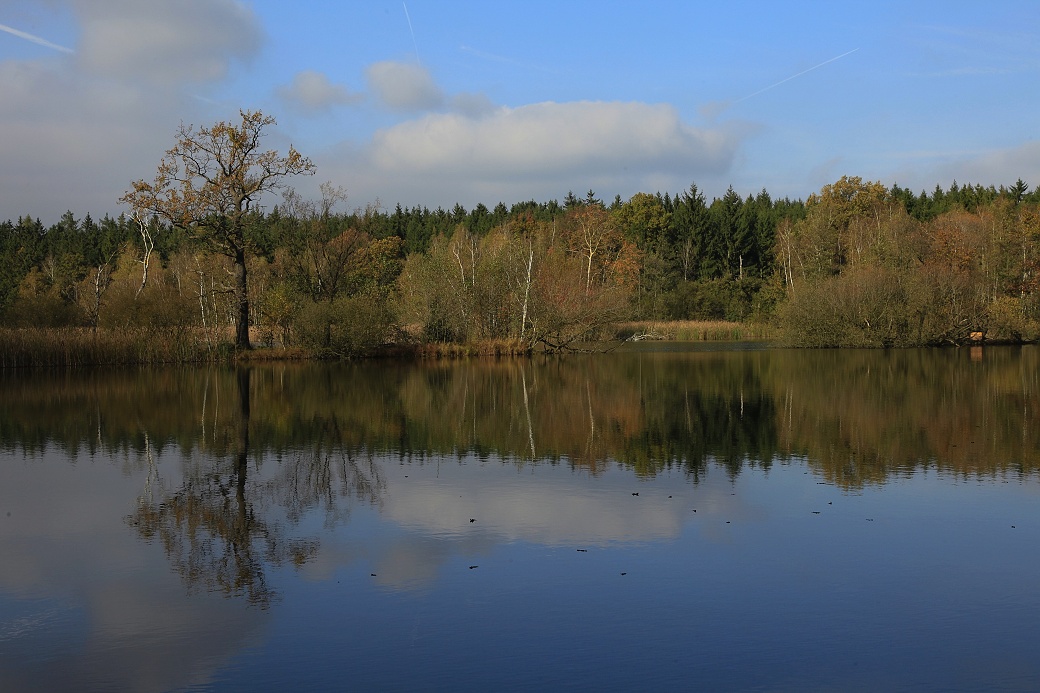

{"left": 777, "top": 178, "right": 1040, "bottom": 347}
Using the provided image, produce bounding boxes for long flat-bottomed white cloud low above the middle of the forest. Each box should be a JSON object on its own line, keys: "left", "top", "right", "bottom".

{"left": 315, "top": 102, "right": 756, "bottom": 208}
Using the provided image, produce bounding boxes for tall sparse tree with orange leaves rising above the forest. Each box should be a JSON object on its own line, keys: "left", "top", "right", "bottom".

{"left": 120, "top": 110, "right": 314, "bottom": 349}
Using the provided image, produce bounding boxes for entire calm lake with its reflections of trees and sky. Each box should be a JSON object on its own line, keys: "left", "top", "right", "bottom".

{"left": 0, "top": 342, "right": 1040, "bottom": 691}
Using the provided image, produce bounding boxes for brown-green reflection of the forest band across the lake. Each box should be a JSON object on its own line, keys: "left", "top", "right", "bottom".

{"left": 0, "top": 347, "right": 1040, "bottom": 482}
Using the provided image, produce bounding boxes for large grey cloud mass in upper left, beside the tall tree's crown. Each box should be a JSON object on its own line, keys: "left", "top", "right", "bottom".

{"left": 0, "top": 0, "right": 261, "bottom": 219}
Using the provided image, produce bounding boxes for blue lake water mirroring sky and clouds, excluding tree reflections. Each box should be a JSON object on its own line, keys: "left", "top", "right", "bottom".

{"left": 6, "top": 445, "right": 1040, "bottom": 691}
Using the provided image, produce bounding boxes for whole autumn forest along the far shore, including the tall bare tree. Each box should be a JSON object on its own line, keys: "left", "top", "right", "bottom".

{"left": 0, "top": 112, "right": 1040, "bottom": 364}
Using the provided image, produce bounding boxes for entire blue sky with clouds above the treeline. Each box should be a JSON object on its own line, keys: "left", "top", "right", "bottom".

{"left": 0, "top": 0, "right": 1040, "bottom": 223}
